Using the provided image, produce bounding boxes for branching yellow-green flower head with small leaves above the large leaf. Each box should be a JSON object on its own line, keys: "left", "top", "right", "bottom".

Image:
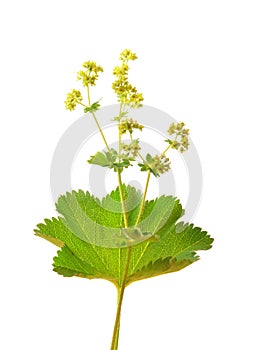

{"left": 65, "top": 49, "right": 189, "bottom": 185}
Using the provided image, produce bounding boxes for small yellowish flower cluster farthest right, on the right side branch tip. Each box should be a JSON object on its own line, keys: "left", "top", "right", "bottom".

{"left": 167, "top": 122, "right": 189, "bottom": 152}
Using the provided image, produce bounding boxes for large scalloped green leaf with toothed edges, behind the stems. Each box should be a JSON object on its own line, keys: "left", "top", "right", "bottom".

{"left": 35, "top": 186, "right": 213, "bottom": 287}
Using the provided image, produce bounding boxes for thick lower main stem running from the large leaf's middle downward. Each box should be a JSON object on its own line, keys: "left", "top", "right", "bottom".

{"left": 110, "top": 247, "right": 132, "bottom": 350}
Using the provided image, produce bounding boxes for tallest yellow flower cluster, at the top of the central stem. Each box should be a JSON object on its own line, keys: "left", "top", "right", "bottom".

{"left": 112, "top": 50, "right": 144, "bottom": 108}
